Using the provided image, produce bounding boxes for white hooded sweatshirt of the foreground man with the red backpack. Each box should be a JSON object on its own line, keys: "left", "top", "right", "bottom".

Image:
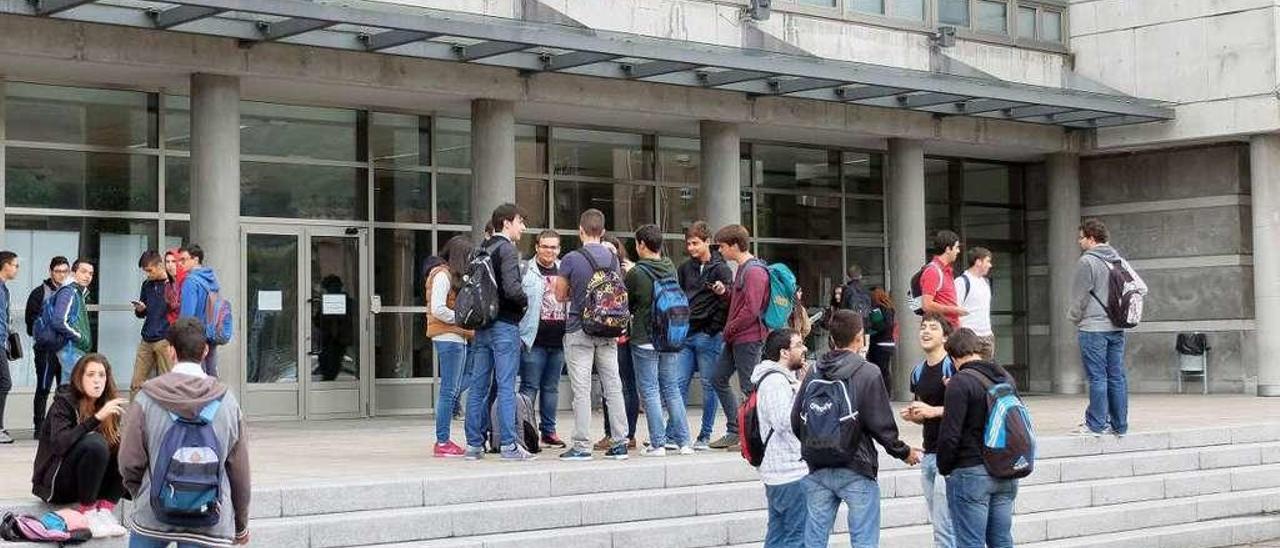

{"left": 751, "top": 360, "right": 809, "bottom": 485}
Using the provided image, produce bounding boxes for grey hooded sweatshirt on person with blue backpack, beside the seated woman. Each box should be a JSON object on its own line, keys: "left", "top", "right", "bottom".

{"left": 119, "top": 362, "right": 250, "bottom": 547}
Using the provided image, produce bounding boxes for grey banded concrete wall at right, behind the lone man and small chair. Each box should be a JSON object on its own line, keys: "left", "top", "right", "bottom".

{"left": 1027, "top": 143, "right": 1257, "bottom": 393}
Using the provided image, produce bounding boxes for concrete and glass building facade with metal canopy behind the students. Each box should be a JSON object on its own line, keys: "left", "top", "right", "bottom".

{"left": 0, "top": 0, "right": 1280, "bottom": 425}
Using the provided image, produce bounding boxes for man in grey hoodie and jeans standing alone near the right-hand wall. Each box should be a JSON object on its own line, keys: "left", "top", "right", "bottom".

{"left": 1068, "top": 219, "right": 1147, "bottom": 437}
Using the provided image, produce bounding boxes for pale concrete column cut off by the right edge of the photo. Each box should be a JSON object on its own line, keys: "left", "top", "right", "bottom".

{"left": 1249, "top": 133, "right": 1280, "bottom": 397}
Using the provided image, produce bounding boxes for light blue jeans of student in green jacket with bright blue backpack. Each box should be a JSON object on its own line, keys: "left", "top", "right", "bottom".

{"left": 631, "top": 344, "right": 689, "bottom": 447}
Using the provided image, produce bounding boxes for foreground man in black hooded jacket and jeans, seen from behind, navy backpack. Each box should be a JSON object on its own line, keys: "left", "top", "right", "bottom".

{"left": 791, "top": 310, "right": 923, "bottom": 547}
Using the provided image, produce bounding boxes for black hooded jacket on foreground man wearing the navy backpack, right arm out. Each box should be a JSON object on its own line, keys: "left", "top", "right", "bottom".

{"left": 791, "top": 350, "right": 911, "bottom": 480}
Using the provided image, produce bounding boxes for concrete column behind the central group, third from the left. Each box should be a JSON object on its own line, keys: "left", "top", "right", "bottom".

{"left": 698, "top": 120, "right": 742, "bottom": 232}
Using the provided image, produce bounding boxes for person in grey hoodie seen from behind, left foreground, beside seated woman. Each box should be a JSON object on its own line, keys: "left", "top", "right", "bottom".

{"left": 120, "top": 318, "right": 250, "bottom": 548}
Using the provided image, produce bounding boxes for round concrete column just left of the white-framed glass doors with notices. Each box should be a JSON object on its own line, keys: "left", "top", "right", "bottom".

{"left": 191, "top": 74, "right": 240, "bottom": 389}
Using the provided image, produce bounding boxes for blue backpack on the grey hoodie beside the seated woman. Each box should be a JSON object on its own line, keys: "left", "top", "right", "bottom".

{"left": 151, "top": 398, "right": 223, "bottom": 528}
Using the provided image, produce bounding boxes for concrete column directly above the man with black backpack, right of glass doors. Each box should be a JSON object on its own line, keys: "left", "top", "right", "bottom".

{"left": 471, "top": 99, "right": 516, "bottom": 236}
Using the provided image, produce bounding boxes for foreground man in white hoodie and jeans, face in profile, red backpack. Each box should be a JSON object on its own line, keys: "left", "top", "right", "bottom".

{"left": 751, "top": 328, "right": 809, "bottom": 548}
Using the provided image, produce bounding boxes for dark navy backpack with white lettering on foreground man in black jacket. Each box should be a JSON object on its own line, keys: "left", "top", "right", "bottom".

{"left": 797, "top": 364, "right": 865, "bottom": 470}
